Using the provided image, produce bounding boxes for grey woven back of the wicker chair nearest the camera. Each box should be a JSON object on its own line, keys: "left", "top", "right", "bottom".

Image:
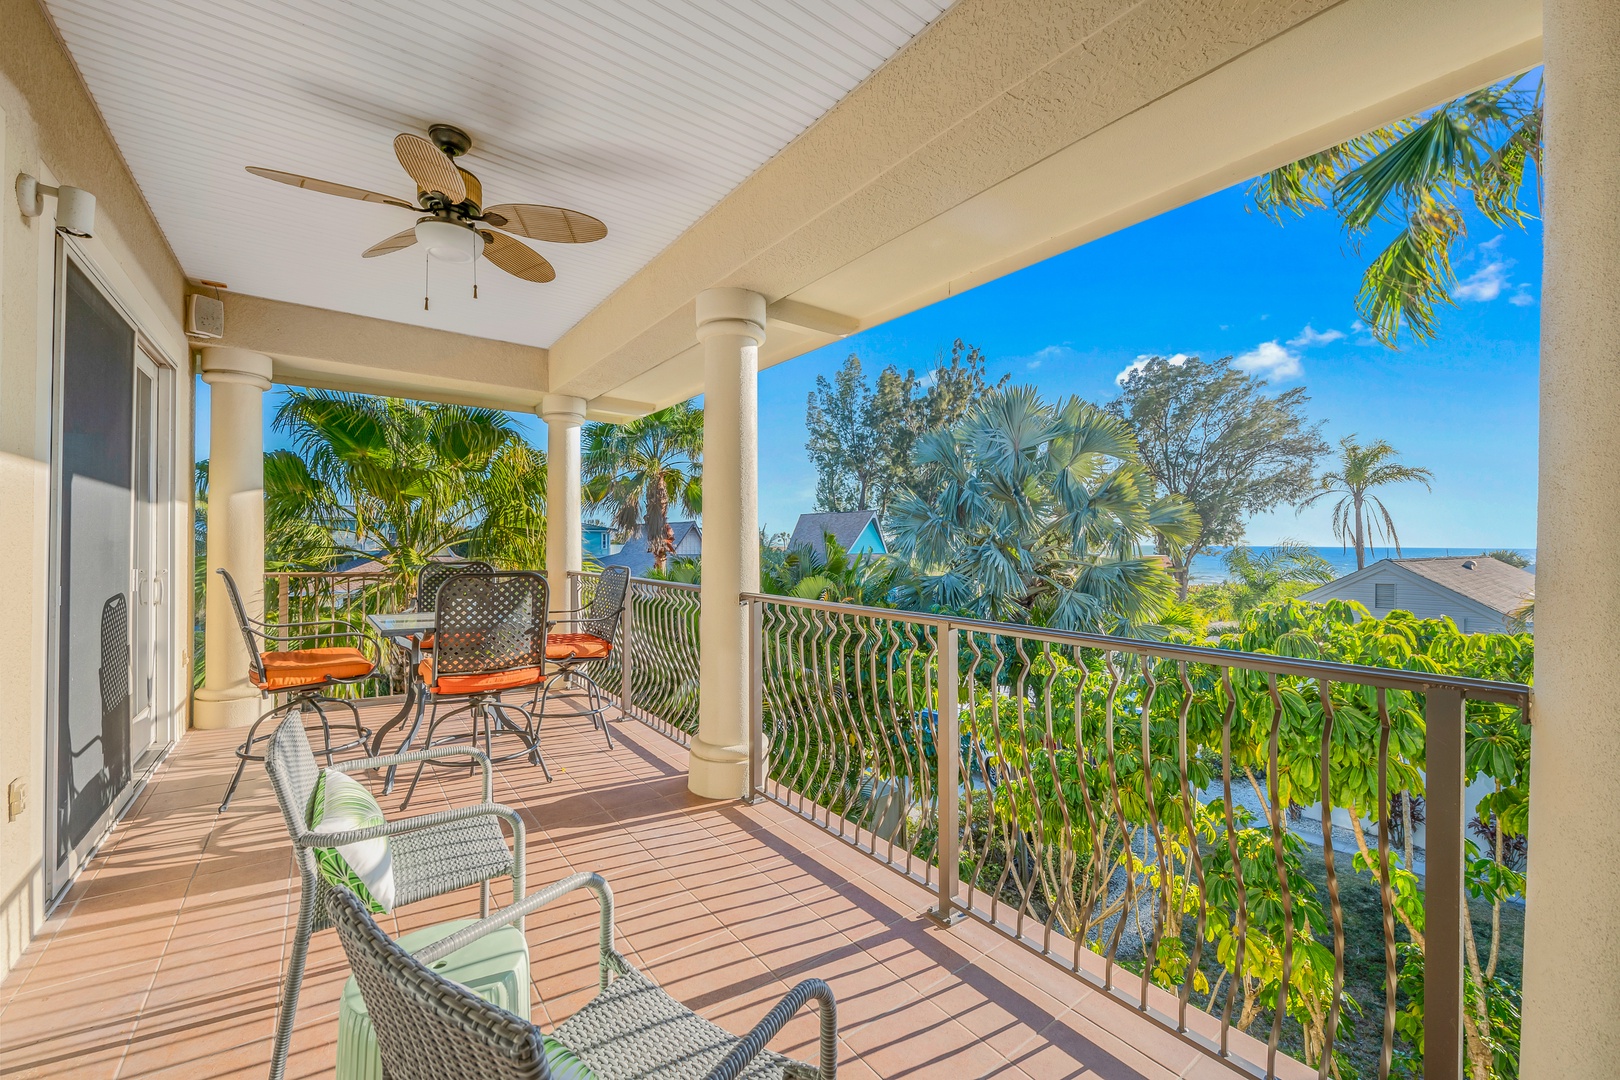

{"left": 330, "top": 889, "right": 552, "bottom": 1080}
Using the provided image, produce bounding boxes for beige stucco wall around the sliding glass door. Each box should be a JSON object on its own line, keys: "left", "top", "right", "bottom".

{"left": 0, "top": 0, "right": 191, "bottom": 976}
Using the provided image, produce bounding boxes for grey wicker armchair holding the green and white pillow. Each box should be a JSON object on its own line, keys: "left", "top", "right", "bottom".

{"left": 264, "top": 712, "right": 523, "bottom": 1080}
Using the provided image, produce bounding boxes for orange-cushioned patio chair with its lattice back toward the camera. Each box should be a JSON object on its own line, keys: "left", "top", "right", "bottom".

{"left": 403, "top": 570, "right": 551, "bottom": 806}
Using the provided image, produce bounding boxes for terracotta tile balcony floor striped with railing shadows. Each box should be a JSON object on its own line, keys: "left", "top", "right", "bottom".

{"left": 0, "top": 706, "right": 1250, "bottom": 1080}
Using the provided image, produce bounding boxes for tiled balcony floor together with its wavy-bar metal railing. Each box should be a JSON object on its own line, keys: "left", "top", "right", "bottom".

{"left": 0, "top": 573, "right": 1528, "bottom": 1077}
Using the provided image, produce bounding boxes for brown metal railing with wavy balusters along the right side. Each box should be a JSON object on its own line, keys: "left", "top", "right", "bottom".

{"left": 578, "top": 575, "right": 1529, "bottom": 1080}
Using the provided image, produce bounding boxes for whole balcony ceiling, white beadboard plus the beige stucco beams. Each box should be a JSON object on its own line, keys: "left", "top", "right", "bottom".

{"left": 47, "top": 0, "right": 1541, "bottom": 419}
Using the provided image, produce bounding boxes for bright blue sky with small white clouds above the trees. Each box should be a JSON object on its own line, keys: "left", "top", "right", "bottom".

{"left": 198, "top": 185, "right": 1541, "bottom": 547}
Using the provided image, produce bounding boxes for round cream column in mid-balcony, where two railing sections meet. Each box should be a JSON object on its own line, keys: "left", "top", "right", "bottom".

{"left": 687, "top": 288, "right": 765, "bottom": 798}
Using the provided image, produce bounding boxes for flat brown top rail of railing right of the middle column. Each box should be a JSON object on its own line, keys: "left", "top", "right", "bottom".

{"left": 741, "top": 583, "right": 1531, "bottom": 712}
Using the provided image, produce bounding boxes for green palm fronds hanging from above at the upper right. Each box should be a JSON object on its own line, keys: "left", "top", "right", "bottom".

{"left": 1249, "top": 76, "right": 1542, "bottom": 347}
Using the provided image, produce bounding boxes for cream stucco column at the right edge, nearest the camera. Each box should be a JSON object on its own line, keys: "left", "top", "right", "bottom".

{"left": 1520, "top": 0, "right": 1620, "bottom": 1080}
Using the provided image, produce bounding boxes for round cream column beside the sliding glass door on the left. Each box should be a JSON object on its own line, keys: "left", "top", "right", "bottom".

{"left": 191, "top": 348, "right": 271, "bottom": 727}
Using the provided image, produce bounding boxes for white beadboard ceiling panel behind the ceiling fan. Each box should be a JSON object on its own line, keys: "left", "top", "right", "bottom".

{"left": 47, "top": 0, "right": 949, "bottom": 347}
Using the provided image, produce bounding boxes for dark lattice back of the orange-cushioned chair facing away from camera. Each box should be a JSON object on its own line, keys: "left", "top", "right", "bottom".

{"left": 433, "top": 570, "right": 551, "bottom": 682}
